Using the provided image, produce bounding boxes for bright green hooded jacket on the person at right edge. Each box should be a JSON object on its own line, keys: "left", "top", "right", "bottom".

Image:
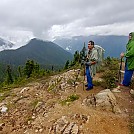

{"left": 124, "top": 32, "right": 134, "bottom": 70}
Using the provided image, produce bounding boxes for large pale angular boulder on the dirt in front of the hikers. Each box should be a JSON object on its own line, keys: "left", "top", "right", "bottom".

{"left": 83, "top": 89, "right": 121, "bottom": 113}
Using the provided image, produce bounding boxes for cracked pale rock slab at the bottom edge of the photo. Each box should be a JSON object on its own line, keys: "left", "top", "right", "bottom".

{"left": 49, "top": 114, "right": 89, "bottom": 134}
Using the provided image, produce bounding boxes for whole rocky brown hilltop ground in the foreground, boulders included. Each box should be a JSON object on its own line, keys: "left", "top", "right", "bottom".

{"left": 0, "top": 70, "right": 134, "bottom": 134}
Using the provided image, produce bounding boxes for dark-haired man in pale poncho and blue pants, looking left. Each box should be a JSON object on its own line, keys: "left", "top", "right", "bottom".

{"left": 85, "top": 41, "right": 98, "bottom": 90}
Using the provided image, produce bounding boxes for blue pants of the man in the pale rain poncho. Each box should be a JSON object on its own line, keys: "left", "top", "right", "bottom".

{"left": 86, "top": 65, "right": 93, "bottom": 88}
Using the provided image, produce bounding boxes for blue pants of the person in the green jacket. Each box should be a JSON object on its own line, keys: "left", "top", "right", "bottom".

{"left": 122, "top": 63, "right": 134, "bottom": 86}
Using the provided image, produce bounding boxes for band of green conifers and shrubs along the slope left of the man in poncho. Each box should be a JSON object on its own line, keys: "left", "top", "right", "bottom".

{"left": 0, "top": 51, "right": 80, "bottom": 92}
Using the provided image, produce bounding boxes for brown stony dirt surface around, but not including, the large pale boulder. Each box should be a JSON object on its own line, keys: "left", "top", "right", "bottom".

{"left": 0, "top": 71, "right": 134, "bottom": 134}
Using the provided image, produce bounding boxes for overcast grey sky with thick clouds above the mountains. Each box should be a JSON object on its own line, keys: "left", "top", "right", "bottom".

{"left": 0, "top": 0, "right": 134, "bottom": 46}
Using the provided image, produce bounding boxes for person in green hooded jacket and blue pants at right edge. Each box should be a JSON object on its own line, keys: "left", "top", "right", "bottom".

{"left": 120, "top": 32, "right": 134, "bottom": 86}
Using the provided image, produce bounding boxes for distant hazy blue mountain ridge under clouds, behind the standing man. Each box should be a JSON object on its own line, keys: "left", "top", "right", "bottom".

{"left": 54, "top": 35, "right": 128, "bottom": 57}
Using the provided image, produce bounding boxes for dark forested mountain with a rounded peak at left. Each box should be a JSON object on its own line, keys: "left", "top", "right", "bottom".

{"left": 0, "top": 38, "right": 73, "bottom": 65}
